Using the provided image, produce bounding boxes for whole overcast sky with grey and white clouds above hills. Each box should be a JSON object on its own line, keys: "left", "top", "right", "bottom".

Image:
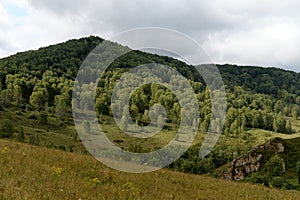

{"left": 0, "top": 0, "right": 300, "bottom": 72}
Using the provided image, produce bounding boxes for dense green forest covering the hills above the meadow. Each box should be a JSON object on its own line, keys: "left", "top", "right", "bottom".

{"left": 0, "top": 36, "right": 300, "bottom": 137}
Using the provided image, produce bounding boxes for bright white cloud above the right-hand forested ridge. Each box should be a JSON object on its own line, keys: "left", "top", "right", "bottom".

{"left": 204, "top": 20, "right": 300, "bottom": 71}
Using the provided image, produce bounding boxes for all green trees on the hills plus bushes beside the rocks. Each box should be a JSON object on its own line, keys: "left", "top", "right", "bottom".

{"left": 0, "top": 36, "right": 300, "bottom": 189}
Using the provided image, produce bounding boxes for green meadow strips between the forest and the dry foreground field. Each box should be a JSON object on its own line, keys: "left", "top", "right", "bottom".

{"left": 0, "top": 107, "right": 300, "bottom": 153}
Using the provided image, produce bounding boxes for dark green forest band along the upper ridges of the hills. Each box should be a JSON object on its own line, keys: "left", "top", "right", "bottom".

{"left": 0, "top": 36, "right": 300, "bottom": 96}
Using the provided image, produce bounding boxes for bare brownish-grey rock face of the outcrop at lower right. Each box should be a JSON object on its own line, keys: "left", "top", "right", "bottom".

{"left": 222, "top": 138, "right": 284, "bottom": 180}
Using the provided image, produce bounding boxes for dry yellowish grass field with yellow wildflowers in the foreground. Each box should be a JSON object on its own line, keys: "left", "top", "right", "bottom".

{"left": 0, "top": 140, "right": 300, "bottom": 199}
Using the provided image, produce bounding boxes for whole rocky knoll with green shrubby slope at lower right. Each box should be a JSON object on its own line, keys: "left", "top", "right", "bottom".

{"left": 220, "top": 137, "right": 300, "bottom": 190}
